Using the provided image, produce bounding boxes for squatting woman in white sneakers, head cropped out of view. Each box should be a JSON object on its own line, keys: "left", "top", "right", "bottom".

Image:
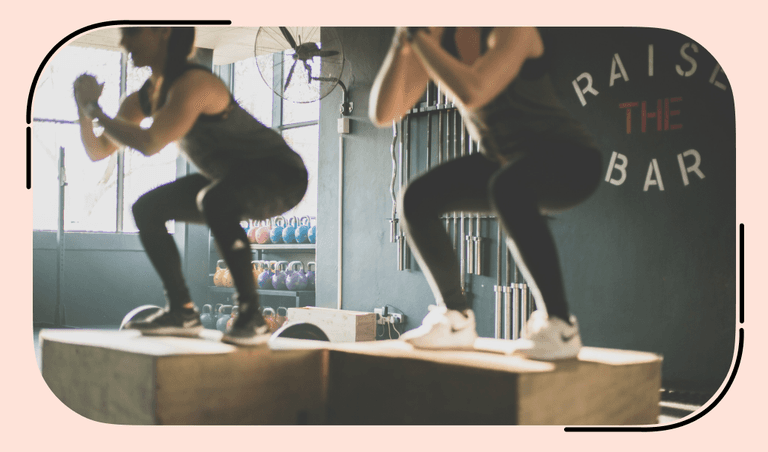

{"left": 370, "top": 27, "right": 601, "bottom": 359}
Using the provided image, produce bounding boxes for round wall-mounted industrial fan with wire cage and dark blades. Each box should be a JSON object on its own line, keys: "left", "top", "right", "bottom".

{"left": 254, "top": 27, "right": 346, "bottom": 103}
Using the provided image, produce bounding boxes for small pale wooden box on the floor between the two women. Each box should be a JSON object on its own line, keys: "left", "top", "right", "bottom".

{"left": 286, "top": 306, "right": 376, "bottom": 342}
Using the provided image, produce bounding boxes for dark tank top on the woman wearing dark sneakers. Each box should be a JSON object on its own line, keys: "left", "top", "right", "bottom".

{"left": 139, "top": 64, "right": 304, "bottom": 180}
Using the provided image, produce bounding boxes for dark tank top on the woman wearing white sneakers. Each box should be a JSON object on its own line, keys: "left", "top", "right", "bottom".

{"left": 442, "top": 28, "right": 594, "bottom": 158}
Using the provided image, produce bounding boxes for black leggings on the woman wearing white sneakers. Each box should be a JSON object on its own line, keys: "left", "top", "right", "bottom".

{"left": 400, "top": 142, "right": 602, "bottom": 320}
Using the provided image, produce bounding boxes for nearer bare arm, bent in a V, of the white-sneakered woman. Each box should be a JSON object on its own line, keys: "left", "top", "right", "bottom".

{"left": 410, "top": 27, "right": 543, "bottom": 110}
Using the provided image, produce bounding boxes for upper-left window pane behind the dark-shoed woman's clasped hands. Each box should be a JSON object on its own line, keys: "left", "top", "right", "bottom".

{"left": 33, "top": 46, "right": 121, "bottom": 121}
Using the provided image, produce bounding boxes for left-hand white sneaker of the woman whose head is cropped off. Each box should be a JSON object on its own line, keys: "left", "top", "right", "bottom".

{"left": 400, "top": 305, "right": 477, "bottom": 349}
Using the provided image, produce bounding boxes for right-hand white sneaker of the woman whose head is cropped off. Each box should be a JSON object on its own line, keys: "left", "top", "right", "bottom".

{"left": 516, "top": 311, "right": 581, "bottom": 361}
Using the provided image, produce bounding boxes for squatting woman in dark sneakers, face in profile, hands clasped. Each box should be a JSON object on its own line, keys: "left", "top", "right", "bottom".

{"left": 74, "top": 28, "right": 307, "bottom": 345}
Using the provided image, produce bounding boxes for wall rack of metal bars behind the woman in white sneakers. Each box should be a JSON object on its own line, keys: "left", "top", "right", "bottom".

{"left": 389, "top": 81, "right": 535, "bottom": 339}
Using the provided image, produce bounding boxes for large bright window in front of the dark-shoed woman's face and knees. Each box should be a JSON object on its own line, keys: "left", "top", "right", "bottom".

{"left": 32, "top": 45, "right": 178, "bottom": 232}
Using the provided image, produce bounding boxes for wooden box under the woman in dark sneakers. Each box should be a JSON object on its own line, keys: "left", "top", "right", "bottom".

{"left": 40, "top": 330, "right": 325, "bottom": 425}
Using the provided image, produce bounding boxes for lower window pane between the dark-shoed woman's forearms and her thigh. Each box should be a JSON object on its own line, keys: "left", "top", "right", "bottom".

{"left": 123, "top": 143, "right": 179, "bottom": 233}
